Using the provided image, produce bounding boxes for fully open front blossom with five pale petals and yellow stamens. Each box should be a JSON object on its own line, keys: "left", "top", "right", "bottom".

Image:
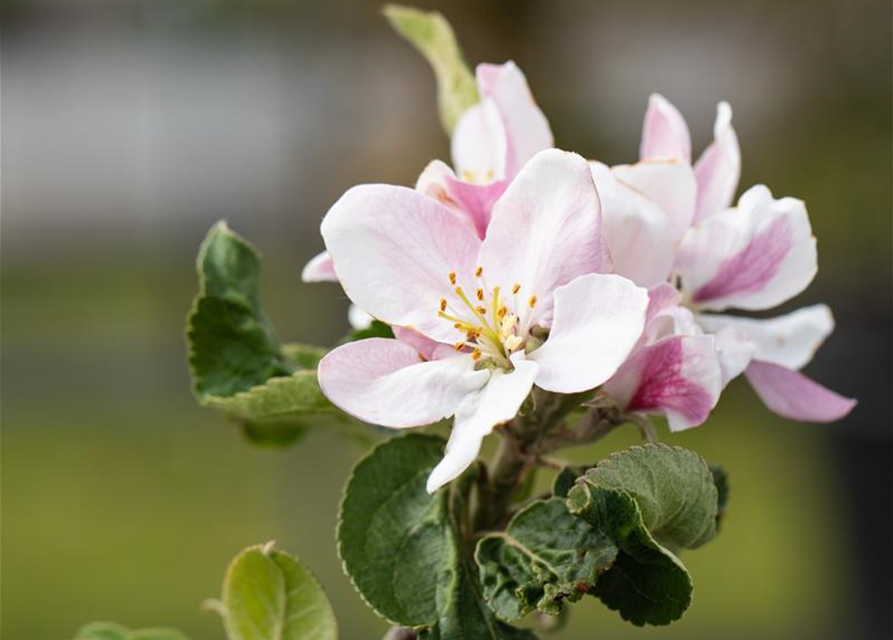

{"left": 319, "top": 150, "right": 648, "bottom": 491}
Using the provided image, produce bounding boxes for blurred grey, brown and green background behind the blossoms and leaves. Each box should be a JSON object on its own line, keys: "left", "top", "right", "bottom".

{"left": 2, "top": 0, "right": 893, "bottom": 640}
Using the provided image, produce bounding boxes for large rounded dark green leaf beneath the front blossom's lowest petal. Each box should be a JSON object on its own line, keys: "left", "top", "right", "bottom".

{"left": 338, "top": 434, "right": 533, "bottom": 640}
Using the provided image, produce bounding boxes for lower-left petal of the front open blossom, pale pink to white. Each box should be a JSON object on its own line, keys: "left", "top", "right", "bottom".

{"left": 319, "top": 338, "right": 489, "bottom": 429}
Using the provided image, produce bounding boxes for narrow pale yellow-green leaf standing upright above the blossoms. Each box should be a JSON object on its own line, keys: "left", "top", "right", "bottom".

{"left": 384, "top": 4, "right": 480, "bottom": 133}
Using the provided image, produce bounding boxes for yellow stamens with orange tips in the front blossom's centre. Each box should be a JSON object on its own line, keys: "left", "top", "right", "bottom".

{"left": 437, "top": 267, "right": 537, "bottom": 369}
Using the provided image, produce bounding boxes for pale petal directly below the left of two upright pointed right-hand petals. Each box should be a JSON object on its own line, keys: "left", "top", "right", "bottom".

{"left": 611, "top": 160, "right": 698, "bottom": 242}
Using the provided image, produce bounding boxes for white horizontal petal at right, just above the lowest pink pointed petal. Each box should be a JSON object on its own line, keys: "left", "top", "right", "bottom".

{"left": 698, "top": 304, "right": 834, "bottom": 370}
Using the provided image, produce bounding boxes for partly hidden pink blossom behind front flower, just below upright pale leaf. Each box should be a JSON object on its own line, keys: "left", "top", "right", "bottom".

{"left": 301, "top": 62, "right": 553, "bottom": 282}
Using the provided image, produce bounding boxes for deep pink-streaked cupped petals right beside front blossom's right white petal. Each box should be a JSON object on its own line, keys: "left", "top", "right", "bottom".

{"left": 604, "top": 283, "right": 722, "bottom": 431}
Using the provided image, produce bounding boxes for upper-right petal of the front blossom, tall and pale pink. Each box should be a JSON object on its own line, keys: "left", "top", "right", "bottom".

{"left": 480, "top": 149, "right": 610, "bottom": 329}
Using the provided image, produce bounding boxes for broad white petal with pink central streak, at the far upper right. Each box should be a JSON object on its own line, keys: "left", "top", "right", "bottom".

{"left": 676, "top": 185, "right": 818, "bottom": 311}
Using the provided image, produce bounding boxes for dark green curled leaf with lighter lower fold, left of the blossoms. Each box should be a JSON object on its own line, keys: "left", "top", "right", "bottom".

{"left": 187, "top": 222, "right": 349, "bottom": 446}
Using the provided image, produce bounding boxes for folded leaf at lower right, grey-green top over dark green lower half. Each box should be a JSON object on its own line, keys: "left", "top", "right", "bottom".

{"left": 567, "top": 444, "right": 717, "bottom": 625}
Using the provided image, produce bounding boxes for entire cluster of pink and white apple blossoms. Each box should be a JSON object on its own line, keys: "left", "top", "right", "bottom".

{"left": 303, "top": 62, "right": 854, "bottom": 491}
